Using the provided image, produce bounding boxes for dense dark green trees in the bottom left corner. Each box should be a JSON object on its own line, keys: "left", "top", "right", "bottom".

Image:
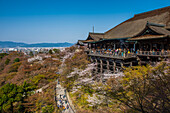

{"left": 0, "top": 82, "right": 35, "bottom": 112}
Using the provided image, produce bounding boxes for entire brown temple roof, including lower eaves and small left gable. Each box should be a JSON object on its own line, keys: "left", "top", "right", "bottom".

{"left": 82, "top": 6, "right": 170, "bottom": 43}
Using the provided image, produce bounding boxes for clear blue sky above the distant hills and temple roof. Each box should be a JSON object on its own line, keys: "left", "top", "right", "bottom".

{"left": 0, "top": 0, "right": 170, "bottom": 43}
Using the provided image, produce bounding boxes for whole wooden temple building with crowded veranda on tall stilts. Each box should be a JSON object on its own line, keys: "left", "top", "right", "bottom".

{"left": 77, "top": 6, "right": 170, "bottom": 73}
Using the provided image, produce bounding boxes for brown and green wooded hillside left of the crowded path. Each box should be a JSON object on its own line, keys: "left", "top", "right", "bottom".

{"left": 0, "top": 50, "right": 61, "bottom": 112}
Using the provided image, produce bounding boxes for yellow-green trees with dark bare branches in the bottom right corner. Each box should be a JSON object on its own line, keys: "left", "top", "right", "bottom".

{"left": 106, "top": 62, "right": 170, "bottom": 113}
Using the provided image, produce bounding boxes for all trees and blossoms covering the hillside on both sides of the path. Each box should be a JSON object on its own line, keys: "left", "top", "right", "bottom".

{"left": 0, "top": 46, "right": 170, "bottom": 113}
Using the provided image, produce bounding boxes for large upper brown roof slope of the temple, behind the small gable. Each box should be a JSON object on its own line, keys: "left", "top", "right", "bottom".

{"left": 104, "top": 6, "right": 170, "bottom": 39}
